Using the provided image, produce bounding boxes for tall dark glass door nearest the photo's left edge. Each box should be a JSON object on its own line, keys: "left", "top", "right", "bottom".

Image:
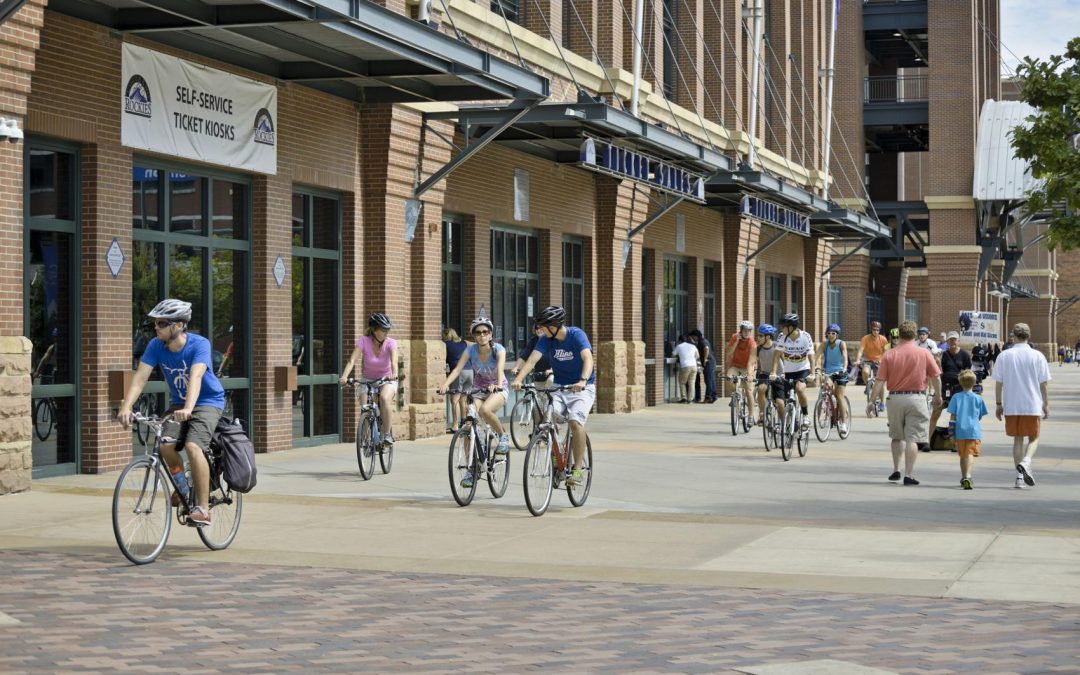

{"left": 23, "top": 143, "right": 80, "bottom": 477}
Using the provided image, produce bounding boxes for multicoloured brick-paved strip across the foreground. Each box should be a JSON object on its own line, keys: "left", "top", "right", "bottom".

{"left": 0, "top": 552, "right": 1080, "bottom": 673}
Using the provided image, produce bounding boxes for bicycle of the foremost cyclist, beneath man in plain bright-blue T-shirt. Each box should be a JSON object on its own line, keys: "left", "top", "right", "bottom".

{"left": 112, "top": 413, "right": 243, "bottom": 565}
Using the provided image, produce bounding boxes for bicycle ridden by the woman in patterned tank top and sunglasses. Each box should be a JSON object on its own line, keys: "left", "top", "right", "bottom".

{"left": 446, "top": 389, "right": 510, "bottom": 507}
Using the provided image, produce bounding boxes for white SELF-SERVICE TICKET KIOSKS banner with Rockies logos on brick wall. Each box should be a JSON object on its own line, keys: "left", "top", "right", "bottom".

{"left": 120, "top": 44, "right": 278, "bottom": 174}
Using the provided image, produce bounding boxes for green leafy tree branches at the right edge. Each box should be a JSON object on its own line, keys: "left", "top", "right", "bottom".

{"left": 1012, "top": 38, "right": 1080, "bottom": 251}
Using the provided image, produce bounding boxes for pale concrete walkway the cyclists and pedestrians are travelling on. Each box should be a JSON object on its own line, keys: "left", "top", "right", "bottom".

{"left": 0, "top": 366, "right": 1080, "bottom": 605}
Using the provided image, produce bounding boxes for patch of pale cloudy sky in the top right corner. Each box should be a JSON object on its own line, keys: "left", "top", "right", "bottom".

{"left": 1001, "top": 0, "right": 1080, "bottom": 75}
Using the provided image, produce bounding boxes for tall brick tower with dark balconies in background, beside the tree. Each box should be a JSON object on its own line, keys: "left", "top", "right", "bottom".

{"left": 816, "top": 0, "right": 1057, "bottom": 356}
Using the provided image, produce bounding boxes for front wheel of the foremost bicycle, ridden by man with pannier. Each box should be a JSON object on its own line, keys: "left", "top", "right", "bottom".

{"left": 112, "top": 457, "right": 173, "bottom": 565}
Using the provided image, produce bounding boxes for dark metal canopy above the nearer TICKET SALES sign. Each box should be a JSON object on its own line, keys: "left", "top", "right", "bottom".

{"left": 427, "top": 100, "right": 731, "bottom": 174}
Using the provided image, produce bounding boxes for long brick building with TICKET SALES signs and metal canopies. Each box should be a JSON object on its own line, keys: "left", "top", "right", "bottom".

{"left": 0, "top": 0, "right": 885, "bottom": 491}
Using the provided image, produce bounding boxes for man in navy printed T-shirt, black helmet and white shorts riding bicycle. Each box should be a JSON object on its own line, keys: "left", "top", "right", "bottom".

{"left": 511, "top": 306, "right": 596, "bottom": 485}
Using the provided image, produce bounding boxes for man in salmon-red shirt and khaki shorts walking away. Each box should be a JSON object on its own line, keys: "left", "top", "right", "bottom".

{"left": 866, "top": 321, "right": 942, "bottom": 485}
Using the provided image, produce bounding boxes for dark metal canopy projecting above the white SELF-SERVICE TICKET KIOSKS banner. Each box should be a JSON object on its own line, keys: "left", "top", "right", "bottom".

{"left": 49, "top": 0, "right": 549, "bottom": 103}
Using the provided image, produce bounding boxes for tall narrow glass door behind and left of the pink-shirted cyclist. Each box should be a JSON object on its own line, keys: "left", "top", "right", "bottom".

{"left": 292, "top": 190, "right": 341, "bottom": 445}
